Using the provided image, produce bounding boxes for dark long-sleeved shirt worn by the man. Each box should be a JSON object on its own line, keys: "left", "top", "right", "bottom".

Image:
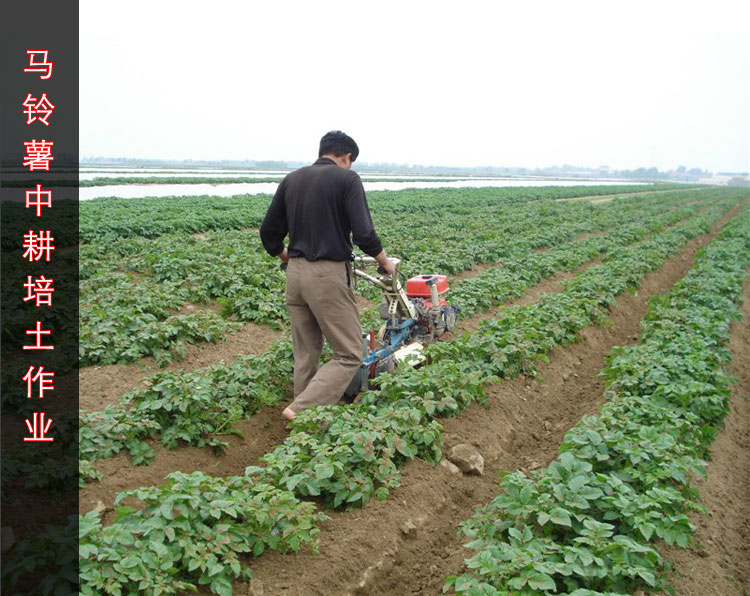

{"left": 260, "top": 157, "right": 383, "bottom": 261}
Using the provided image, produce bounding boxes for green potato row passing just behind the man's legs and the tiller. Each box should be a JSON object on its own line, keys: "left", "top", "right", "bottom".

{"left": 80, "top": 194, "right": 720, "bottom": 477}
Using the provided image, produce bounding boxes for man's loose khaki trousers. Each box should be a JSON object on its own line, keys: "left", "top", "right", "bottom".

{"left": 286, "top": 257, "right": 362, "bottom": 414}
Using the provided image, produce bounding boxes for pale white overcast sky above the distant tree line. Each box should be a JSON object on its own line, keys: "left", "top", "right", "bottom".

{"left": 80, "top": 0, "right": 750, "bottom": 172}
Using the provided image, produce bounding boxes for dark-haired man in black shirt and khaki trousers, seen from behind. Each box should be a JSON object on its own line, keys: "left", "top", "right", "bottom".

{"left": 260, "top": 130, "right": 394, "bottom": 420}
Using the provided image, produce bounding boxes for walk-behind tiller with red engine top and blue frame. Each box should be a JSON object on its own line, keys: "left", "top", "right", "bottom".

{"left": 345, "top": 257, "right": 456, "bottom": 397}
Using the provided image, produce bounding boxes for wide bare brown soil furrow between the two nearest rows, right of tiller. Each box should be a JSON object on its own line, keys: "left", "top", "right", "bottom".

{"left": 235, "top": 208, "right": 740, "bottom": 595}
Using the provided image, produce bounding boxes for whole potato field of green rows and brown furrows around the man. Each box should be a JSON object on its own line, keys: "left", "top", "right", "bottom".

{"left": 3, "top": 186, "right": 750, "bottom": 596}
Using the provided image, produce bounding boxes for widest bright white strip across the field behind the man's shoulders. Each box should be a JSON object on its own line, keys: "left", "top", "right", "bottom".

{"left": 79, "top": 174, "right": 642, "bottom": 201}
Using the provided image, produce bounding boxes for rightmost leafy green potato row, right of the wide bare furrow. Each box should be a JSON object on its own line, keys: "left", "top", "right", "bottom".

{"left": 446, "top": 203, "right": 750, "bottom": 596}
